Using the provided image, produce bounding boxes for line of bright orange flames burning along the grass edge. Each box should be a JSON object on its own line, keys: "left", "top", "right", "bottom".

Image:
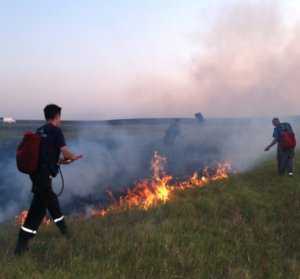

{"left": 16, "top": 152, "right": 231, "bottom": 224}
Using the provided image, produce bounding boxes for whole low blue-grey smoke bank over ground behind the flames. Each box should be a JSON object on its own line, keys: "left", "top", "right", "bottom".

{"left": 0, "top": 119, "right": 300, "bottom": 222}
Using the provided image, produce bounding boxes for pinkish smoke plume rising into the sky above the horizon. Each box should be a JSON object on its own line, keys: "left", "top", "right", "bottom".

{"left": 125, "top": 0, "right": 300, "bottom": 117}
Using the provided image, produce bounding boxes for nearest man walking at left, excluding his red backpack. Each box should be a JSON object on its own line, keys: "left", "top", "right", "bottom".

{"left": 15, "top": 104, "right": 82, "bottom": 255}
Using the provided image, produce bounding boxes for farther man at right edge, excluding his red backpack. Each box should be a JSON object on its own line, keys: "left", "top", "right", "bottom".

{"left": 265, "top": 118, "right": 295, "bottom": 176}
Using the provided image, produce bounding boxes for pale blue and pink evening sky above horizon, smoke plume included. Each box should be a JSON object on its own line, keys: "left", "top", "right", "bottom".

{"left": 0, "top": 0, "right": 300, "bottom": 120}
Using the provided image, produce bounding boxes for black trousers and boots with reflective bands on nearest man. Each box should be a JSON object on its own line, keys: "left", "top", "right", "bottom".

{"left": 16, "top": 168, "right": 67, "bottom": 254}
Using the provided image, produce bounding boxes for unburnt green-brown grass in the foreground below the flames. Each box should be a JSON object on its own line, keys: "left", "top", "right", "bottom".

{"left": 0, "top": 153, "right": 300, "bottom": 279}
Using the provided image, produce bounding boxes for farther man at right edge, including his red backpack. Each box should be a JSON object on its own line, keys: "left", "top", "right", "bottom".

{"left": 265, "top": 118, "right": 296, "bottom": 176}
